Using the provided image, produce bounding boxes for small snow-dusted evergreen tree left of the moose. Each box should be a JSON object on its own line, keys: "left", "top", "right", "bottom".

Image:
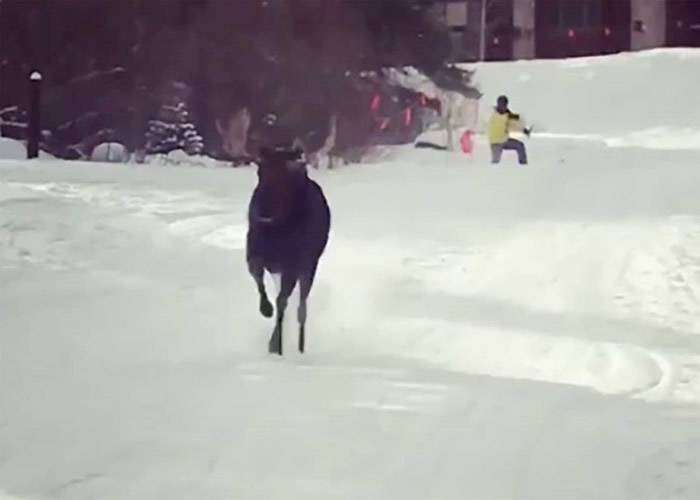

{"left": 146, "top": 99, "right": 204, "bottom": 155}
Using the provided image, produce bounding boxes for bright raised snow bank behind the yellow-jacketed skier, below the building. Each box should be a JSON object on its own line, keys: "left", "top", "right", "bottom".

{"left": 465, "top": 49, "right": 700, "bottom": 142}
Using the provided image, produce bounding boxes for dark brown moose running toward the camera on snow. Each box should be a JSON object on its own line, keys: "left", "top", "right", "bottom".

{"left": 246, "top": 147, "right": 331, "bottom": 356}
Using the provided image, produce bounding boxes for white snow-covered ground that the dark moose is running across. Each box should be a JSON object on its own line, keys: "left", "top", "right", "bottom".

{"left": 0, "top": 48, "right": 700, "bottom": 500}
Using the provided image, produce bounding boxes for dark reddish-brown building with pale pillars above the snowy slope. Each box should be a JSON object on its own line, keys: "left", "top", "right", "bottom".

{"left": 435, "top": 0, "right": 700, "bottom": 61}
